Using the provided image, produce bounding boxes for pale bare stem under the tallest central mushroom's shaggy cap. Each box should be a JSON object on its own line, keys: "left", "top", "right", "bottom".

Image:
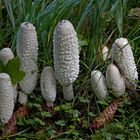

{"left": 63, "top": 84, "right": 74, "bottom": 101}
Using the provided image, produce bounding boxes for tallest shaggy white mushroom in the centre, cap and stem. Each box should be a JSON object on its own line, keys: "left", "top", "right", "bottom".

{"left": 53, "top": 20, "right": 79, "bottom": 100}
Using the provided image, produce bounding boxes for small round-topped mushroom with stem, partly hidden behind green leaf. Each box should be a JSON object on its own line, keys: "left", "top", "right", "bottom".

{"left": 0, "top": 48, "right": 18, "bottom": 103}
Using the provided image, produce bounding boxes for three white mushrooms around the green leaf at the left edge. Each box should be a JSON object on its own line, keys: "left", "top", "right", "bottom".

{"left": 0, "top": 22, "right": 38, "bottom": 124}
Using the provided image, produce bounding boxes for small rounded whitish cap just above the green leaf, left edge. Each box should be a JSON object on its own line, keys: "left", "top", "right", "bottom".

{"left": 0, "top": 48, "right": 14, "bottom": 65}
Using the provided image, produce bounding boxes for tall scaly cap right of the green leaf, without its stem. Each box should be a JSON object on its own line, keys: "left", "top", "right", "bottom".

{"left": 16, "top": 22, "right": 38, "bottom": 94}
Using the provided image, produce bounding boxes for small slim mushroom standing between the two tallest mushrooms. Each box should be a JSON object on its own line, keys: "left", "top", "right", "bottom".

{"left": 40, "top": 66, "right": 56, "bottom": 107}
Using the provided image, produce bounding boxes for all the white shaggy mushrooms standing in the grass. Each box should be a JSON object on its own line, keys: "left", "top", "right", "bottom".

{"left": 0, "top": 20, "right": 138, "bottom": 124}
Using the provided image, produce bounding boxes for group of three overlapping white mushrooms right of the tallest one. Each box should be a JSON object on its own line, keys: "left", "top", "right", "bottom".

{"left": 91, "top": 38, "right": 138, "bottom": 99}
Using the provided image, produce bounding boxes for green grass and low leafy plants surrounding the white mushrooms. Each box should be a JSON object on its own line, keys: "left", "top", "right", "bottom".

{"left": 0, "top": 0, "right": 140, "bottom": 140}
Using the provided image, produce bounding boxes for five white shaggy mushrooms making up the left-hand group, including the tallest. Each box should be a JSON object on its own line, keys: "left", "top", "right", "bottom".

{"left": 0, "top": 20, "right": 79, "bottom": 124}
